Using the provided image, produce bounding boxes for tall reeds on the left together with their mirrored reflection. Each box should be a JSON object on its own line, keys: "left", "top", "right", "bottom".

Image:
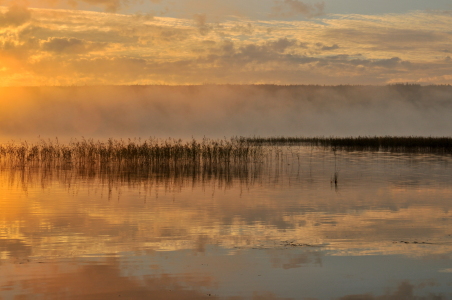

{"left": 0, "top": 138, "right": 266, "bottom": 189}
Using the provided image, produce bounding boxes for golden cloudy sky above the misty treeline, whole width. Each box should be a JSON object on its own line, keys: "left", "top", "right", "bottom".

{"left": 0, "top": 0, "right": 452, "bottom": 86}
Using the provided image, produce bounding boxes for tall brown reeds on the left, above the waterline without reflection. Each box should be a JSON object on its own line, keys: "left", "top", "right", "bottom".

{"left": 0, "top": 138, "right": 263, "bottom": 165}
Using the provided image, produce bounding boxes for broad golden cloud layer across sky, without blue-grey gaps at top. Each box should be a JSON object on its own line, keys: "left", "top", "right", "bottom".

{"left": 0, "top": 7, "right": 452, "bottom": 85}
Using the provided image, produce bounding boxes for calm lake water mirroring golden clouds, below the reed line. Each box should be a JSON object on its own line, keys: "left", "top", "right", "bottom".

{"left": 0, "top": 146, "right": 452, "bottom": 299}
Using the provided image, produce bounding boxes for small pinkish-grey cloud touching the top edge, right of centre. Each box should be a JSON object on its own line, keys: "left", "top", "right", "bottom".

{"left": 270, "top": 0, "right": 325, "bottom": 18}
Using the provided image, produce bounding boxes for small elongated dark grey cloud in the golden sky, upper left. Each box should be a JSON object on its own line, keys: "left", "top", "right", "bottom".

{"left": 42, "top": 38, "right": 106, "bottom": 54}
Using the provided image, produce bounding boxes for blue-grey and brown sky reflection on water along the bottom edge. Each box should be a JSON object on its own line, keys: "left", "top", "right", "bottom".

{"left": 0, "top": 251, "right": 450, "bottom": 299}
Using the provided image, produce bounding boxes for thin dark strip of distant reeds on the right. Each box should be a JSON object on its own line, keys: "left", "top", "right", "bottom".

{"left": 243, "top": 136, "right": 452, "bottom": 153}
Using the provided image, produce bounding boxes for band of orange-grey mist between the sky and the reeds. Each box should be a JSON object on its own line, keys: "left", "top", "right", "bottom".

{"left": 0, "top": 85, "right": 452, "bottom": 140}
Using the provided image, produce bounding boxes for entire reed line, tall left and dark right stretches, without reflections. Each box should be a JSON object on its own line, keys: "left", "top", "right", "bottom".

{"left": 4, "top": 136, "right": 452, "bottom": 167}
